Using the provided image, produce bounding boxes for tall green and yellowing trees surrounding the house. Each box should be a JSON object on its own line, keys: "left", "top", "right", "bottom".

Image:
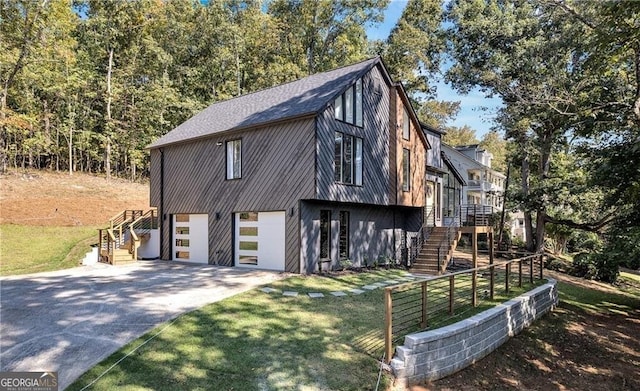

{"left": 0, "top": 0, "right": 640, "bottom": 280}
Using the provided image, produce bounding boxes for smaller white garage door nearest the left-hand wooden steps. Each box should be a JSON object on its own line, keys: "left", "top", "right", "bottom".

{"left": 173, "top": 214, "right": 209, "bottom": 263}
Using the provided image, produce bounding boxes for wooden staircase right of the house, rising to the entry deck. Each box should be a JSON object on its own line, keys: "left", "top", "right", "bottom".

{"left": 411, "top": 227, "right": 461, "bottom": 275}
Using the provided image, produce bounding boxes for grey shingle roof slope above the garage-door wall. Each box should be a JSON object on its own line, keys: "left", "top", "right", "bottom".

{"left": 148, "top": 57, "right": 380, "bottom": 148}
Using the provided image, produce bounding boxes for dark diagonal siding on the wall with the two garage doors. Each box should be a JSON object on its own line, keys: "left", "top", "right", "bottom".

{"left": 152, "top": 119, "right": 315, "bottom": 272}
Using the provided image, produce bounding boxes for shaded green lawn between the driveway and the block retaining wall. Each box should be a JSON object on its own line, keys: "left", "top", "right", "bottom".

{"left": 68, "top": 270, "right": 552, "bottom": 390}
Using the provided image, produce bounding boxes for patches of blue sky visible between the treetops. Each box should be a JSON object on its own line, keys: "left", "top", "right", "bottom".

{"left": 367, "top": 0, "right": 501, "bottom": 139}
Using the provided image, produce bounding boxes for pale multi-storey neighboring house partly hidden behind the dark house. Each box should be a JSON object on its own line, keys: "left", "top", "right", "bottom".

{"left": 442, "top": 144, "right": 506, "bottom": 213}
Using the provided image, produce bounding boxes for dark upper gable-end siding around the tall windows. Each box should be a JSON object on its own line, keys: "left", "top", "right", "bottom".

{"left": 316, "top": 67, "right": 389, "bottom": 205}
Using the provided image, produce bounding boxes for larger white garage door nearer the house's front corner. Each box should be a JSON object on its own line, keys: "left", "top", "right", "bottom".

{"left": 234, "top": 212, "right": 285, "bottom": 270}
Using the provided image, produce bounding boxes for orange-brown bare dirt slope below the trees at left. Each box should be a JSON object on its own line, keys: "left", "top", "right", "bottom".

{"left": 0, "top": 171, "right": 149, "bottom": 226}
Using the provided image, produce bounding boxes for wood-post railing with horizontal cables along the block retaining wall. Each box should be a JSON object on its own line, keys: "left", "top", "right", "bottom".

{"left": 384, "top": 254, "right": 544, "bottom": 362}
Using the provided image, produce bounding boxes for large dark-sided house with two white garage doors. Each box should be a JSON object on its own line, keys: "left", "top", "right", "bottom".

{"left": 149, "top": 58, "right": 432, "bottom": 273}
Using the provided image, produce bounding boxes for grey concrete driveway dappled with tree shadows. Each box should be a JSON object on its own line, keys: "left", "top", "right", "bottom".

{"left": 0, "top": 261, "right": 282, "bottom": 390}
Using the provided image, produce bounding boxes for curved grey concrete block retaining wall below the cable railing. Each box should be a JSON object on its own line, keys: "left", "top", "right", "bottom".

{"left": 391, "top": 279, "right": 558, "bottom": 384}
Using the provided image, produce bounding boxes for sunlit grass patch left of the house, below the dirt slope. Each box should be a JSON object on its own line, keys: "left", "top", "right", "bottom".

{"left": 0, "top": 224, "right": 98, "bottom": 276}
